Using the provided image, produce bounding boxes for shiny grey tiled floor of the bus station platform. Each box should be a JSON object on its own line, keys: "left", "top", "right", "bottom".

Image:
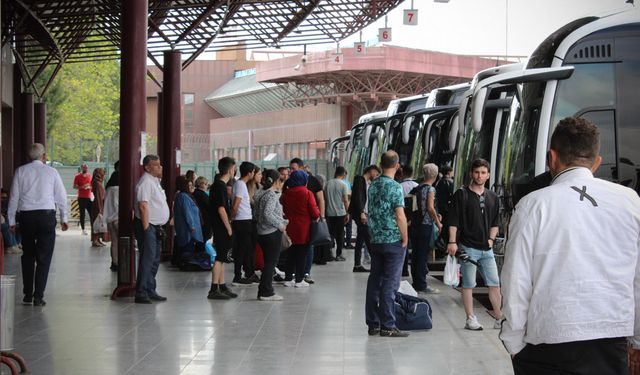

{"left": 2, "top": 230, "right": 512, "bottom": 375}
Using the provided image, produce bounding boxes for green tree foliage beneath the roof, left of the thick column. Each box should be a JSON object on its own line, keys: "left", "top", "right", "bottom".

{"left": 44, "top": 60, "right": 120, "bottom": 164}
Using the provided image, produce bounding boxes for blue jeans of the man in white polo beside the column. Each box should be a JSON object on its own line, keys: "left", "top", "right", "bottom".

{"left": 134, "top": 218, "right": 162, "bottom": 297}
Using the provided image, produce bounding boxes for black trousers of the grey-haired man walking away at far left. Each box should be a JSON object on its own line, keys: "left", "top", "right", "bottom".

{"left": 18, "top": 210, "right": 56, "bottom": 299}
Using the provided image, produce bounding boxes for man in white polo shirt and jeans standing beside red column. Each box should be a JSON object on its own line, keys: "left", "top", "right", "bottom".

{"left": 134, "top": 155, "right": 169, "bottom": 304}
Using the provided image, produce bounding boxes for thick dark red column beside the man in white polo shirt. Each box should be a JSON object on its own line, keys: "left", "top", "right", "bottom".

{"left": 111, "top": 0, "right": 149, "bottom": 298}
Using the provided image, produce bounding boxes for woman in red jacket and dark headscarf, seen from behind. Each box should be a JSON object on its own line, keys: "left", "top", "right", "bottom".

{"left": 282, "top": 170, "right": 320, "bottom": 288}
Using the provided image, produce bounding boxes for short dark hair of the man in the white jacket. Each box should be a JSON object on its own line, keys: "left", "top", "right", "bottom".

{"left": 551, "top": 117, "right": 600, "bottom": 165}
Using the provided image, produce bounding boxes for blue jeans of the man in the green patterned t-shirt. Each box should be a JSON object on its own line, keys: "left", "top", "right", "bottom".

{"left": 365, "top": 242, "right": 406, "bottom": 329}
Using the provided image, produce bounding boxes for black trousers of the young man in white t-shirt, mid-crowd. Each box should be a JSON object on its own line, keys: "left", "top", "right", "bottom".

{"left": 231, "top": 220, "right": 256, "bottom": 279}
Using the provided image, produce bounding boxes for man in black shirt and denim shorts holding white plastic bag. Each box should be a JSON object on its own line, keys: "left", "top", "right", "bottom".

{"left": 447, "top": 159, "right": 502, "bottom": 331}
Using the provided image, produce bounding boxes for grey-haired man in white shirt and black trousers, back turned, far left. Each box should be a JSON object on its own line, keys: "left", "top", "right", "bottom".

{"left": 7, "top": 143, "right": 69, "bottom": 306}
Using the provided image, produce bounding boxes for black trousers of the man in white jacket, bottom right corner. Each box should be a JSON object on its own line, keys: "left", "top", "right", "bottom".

{"left": 512, "top": 337, "right": 629, "bottom": 375}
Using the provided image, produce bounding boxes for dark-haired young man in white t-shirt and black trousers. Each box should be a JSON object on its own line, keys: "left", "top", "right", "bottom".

{"left": 231, "top": 161, "right": 260, "bottom": 285}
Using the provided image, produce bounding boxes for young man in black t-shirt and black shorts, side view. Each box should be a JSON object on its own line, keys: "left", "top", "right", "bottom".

{"left": 207, "top": 156, "right": 238, "bottom": 300}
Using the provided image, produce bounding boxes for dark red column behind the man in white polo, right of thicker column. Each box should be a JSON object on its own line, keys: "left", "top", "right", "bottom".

{"left": 158, "top": 51, "right": 182, "bottom": 259}
